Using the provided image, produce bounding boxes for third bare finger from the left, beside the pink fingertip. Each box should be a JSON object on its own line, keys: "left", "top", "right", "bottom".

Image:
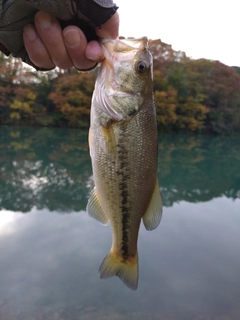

{"left": 63, "top": 26, "right": 99, "bottom": 70}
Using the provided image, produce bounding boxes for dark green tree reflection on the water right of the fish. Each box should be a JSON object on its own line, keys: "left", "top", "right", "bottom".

{"left": 159, "top": 135, "right": 240, "bottom": 206}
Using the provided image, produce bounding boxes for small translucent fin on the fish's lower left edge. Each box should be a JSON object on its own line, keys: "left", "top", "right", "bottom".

{"left": 87, "top": 188, "right": 108, "bottom": 226}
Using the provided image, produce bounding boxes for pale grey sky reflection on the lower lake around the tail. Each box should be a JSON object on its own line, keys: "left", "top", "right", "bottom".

{"left": 0, "top": 197, "right": 240, "bottom": 320}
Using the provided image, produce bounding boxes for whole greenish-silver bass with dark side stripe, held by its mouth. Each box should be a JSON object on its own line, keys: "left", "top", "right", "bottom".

{"left": 87, "top": 37, "right": 162, "bottom": 290}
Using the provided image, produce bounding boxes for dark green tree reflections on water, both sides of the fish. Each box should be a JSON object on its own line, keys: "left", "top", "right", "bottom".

{"left": 0, "top": 127, "right": 240, "bottom": 213}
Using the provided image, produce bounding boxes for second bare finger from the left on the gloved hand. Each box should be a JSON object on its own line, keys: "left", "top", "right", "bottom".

{"left": 34, "top": 11, "right": 73, "bottom": 69}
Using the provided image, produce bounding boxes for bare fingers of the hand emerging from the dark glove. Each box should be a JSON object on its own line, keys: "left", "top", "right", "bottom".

{"left": 23, "top": 11, "right": 119, "bottom": 70}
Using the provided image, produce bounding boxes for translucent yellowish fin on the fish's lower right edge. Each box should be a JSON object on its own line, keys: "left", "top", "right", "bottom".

{"left": 142, "top": 180, "right": 162, "bottom": 230}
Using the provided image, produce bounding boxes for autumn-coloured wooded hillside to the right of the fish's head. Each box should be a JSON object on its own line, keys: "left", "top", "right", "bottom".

{"left": 150, "top": 40, "right": 240, "bottom": 134}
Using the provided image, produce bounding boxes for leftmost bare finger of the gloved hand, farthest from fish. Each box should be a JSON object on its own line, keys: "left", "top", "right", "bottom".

{"left": 23, "top": 25, "right": 55, "bottom": 69}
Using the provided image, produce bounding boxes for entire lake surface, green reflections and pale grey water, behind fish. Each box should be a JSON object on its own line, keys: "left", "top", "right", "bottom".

{"left": 0, "top": 127, "right": 240, "bottom": 320}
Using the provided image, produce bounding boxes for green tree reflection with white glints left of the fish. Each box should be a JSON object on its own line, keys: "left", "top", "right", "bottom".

{"left": 0, "top": 128, "right": 93, "bottom": 213}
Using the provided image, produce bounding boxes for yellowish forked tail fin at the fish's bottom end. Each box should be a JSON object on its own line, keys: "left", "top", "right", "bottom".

{"left": 99, "top": 251, "right": 138, "bottom": 290}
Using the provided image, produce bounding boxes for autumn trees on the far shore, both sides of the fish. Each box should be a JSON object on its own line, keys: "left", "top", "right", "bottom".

{"left": 0, "top": 40, "right": 240, "bottom": 134}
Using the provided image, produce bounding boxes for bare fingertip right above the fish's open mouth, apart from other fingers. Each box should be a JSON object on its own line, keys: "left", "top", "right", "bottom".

{"left": 95, "top": 12, "right": 119, "bottom": 39}
